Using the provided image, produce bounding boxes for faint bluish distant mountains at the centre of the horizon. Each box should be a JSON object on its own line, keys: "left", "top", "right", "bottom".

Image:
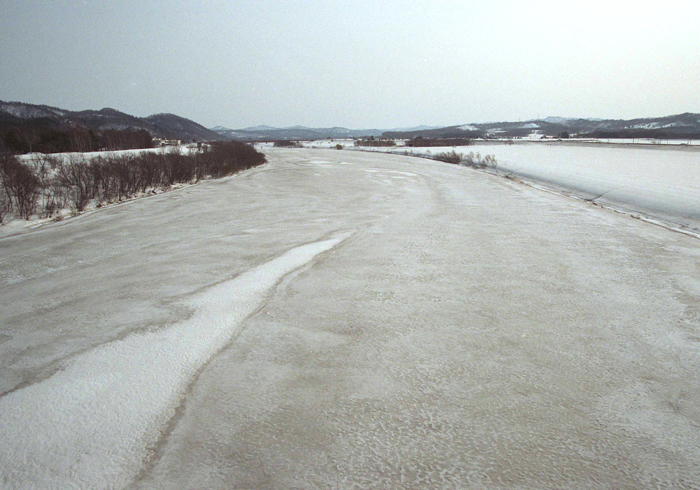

{"left": 211, "top": 126, "right": 383, "bottom": 141}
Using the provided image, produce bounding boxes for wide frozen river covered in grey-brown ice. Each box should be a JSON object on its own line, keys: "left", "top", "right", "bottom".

{"left": 0, "top": 147, "right": 700, "bottom": 490}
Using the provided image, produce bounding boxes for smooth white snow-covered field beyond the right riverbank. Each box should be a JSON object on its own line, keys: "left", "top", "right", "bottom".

{"left": 358, "top": 142, "right": 700, "bottom": 232}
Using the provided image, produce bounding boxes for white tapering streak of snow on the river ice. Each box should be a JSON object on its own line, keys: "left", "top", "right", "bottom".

{"left": 0, "top": 233, "right": 350, "bottom": 489}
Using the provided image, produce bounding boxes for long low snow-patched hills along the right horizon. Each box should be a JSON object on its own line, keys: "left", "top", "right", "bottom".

{"left": 382, "top": 113, "right": 700, "bottom": 139}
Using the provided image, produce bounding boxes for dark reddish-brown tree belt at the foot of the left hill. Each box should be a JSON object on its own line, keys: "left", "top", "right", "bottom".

{"left": 0, "top": 120, "right": 153, "bottom": 153}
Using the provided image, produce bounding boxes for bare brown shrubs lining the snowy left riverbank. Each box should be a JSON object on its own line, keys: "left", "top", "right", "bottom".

{"left": 0, "top": 141, "right": 265, "bottom": 223}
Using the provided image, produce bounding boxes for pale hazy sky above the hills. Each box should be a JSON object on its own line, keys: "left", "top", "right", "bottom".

{"left": 0, "top": 0, "right": 700, "bottom": 129}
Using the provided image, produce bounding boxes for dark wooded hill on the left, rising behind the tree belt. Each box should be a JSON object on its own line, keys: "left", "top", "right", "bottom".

{"left": 0, "top": 101, "right": 223, "bottom": 141}
